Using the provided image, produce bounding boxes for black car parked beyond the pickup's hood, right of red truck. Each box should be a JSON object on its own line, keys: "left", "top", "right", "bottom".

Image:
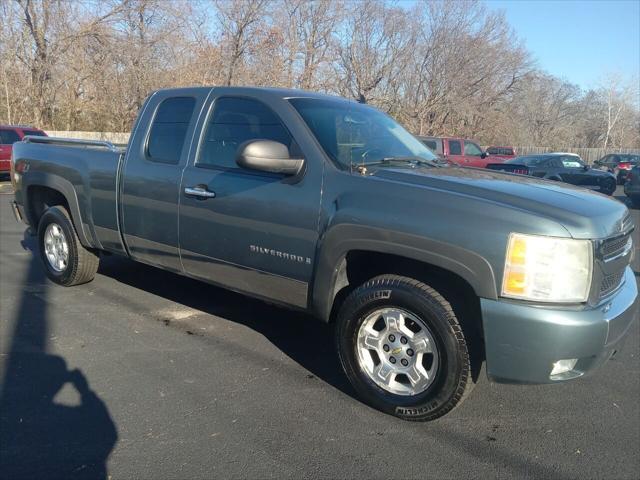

{"left": 487, "top": 153, "right": 616, "bottom": 195}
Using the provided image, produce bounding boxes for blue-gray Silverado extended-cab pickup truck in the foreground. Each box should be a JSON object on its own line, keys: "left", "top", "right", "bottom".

{"left": 12, "top": 88, "right": 638, "bottom": 420}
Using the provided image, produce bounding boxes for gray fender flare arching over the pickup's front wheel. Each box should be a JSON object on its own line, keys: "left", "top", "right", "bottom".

{"left": 310, "top": 224, "right": 498, "bottom": 321}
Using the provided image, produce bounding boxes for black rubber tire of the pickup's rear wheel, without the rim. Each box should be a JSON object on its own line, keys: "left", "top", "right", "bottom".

{"left": 38, "top": 206, "right": 100, "bottom": 287}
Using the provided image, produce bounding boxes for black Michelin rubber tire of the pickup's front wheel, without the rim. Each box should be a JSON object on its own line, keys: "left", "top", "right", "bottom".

{"left": 336, "top": 275, "right": 474, "bottom": 421}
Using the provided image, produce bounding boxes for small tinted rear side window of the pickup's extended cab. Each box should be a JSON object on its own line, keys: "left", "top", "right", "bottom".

{"left": 145, "top": 97, "right": 196, "bottom": 165}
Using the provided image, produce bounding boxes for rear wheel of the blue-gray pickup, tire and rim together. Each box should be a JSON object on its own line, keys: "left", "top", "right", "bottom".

{"left": 38, "top": 206, "right": 100, "bottom": 287}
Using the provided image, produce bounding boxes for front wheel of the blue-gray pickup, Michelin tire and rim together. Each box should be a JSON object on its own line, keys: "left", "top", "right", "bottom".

{"left": 336, "top": 275, "right": 473, "bottom": 421}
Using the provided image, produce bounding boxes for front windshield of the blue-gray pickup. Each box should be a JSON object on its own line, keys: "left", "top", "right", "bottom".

{"left": 289, "top": 98, "right": 437, "bottom": 168}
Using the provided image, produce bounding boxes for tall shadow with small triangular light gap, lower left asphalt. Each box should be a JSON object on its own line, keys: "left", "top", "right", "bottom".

{"left": 0, "top": 236, "right": 118, "bottom": 479}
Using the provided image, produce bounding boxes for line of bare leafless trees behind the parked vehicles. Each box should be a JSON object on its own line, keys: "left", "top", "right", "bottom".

{"left": 0, "top": 0, "right": 640, "bottom": 148}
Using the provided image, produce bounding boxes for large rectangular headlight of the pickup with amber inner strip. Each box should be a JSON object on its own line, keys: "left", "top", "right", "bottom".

{"left": 502, "top": 233, "right": 593, "bottom": 303}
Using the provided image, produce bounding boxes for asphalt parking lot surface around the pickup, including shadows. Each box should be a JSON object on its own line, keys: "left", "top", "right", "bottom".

{"left": 0, "top": 184, "right": 640, "bottom": 479}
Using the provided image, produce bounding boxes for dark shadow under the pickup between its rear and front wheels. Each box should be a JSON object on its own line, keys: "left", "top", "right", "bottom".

{"left": 98, "top": 256, "right": 356, "bottom": 398}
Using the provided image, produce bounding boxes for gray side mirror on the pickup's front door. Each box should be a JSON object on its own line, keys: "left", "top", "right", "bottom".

{"left": 236, "top": 140, "right": 304, "bottom": 175}
